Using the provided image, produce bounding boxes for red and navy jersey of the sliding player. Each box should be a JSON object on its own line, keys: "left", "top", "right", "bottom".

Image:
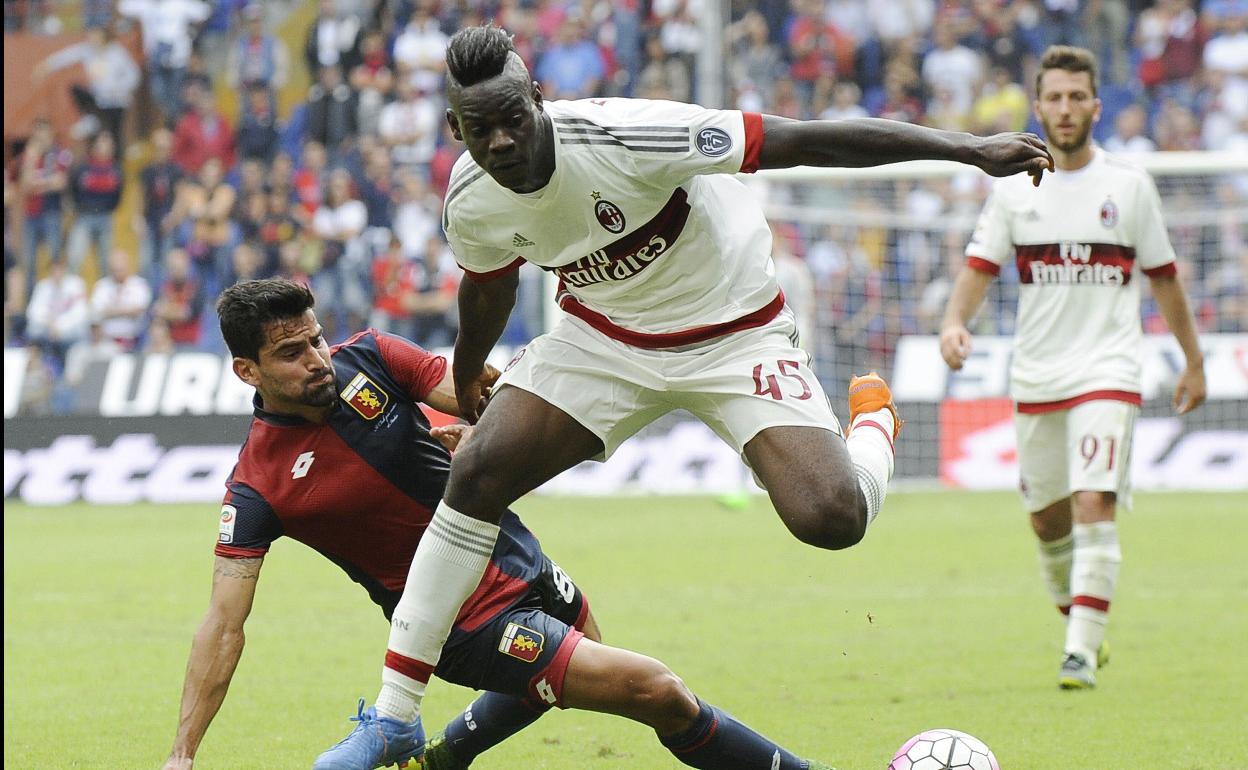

{"left": 216, "top": 329, "right": 543, "bottom": 630}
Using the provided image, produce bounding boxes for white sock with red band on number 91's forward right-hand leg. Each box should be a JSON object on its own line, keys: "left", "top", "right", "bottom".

{"left": 1066, "top": 520, "right": 1122, "bottom": 666}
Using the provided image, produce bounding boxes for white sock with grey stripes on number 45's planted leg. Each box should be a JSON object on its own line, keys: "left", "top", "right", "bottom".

{"left": 377, "top": 503, "right": 498, "bottom": 723}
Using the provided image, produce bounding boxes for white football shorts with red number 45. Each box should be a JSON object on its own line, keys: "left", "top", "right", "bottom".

{"left": 495, "top": 307, "right": 841, "bottom": 461}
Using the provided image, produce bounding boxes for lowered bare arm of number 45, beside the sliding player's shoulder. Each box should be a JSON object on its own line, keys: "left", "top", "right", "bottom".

{"left": 451, "top": 271, "right": 520, "bottom": 423}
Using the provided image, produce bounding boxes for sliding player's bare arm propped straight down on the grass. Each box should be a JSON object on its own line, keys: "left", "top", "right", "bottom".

{"left": 163, "top": 557, "right": 265, "bottom": 770}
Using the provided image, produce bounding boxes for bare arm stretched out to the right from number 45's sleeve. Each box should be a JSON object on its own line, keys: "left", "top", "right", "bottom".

{"left": 759, "top": 115, "right": 1053, "bottom": 185}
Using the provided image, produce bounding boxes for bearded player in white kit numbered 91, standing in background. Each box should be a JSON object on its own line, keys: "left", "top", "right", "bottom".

{"left": 941, "top": 46, "right": 1206, "bottom": 689}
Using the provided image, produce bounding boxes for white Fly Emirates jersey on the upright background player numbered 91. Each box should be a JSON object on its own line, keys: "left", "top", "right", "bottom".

{"left": 966, "top": 149, "right": 1174, "bottom": 404}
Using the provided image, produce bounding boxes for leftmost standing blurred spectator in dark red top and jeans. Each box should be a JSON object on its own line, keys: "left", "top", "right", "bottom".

{"left": 16, "top": 119, "right": 74, "bottom": 300}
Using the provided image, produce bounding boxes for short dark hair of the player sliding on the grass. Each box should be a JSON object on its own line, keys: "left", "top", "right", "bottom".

{"left": 217, "top": 278, "right": 316, "bottom": 361}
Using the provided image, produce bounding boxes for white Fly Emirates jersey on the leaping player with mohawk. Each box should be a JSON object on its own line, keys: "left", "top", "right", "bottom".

{"left": 442, "top": 99, "right": 784, "bottom": 348}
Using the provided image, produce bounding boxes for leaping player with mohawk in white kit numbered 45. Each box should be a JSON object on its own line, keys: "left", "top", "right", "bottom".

{"left": 316, "top": 25, "right": 1052, "bottom": 770}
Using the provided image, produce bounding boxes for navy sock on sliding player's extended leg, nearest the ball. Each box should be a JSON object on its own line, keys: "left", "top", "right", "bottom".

{"left": 659, "top": 699, "right": 809, "bottom": 770}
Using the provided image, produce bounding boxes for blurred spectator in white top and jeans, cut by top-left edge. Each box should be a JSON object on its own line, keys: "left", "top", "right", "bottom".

{"left": 117, "top": 0, "right": 212, "bottom": 121}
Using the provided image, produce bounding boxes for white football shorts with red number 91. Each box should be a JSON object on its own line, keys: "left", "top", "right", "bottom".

{"left": 1015, "top": 401, "right": 1139, "bottom": 513}
